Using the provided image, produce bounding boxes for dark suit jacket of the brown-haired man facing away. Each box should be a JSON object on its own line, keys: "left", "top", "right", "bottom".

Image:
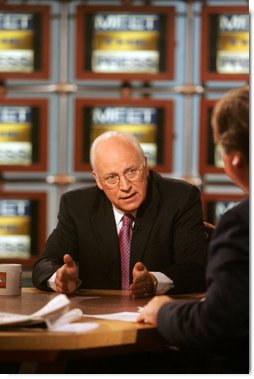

{"left": 158, "top": 200, "right": 249, "bottom": 359}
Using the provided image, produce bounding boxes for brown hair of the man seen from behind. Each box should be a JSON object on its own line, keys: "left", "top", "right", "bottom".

{"left": 212, "top": 86, "right": 249, "bottom": 164}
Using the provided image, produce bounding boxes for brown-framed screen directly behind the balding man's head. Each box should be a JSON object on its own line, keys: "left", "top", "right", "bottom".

{"left": 73, "top": 98, "right": 173, "bottom": 172}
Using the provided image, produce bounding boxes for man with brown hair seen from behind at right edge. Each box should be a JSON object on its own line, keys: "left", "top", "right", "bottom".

{"left": 138, "top": 87, "right": 249, "bottom": 373}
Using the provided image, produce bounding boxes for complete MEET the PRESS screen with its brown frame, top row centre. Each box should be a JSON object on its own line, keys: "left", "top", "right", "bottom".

{"left": 76, "top": 5, "right": 175, "bottom": 80}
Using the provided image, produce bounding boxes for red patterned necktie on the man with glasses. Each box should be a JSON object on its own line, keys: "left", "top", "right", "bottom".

{"left": 119, "top": 214, "right": 134, "bottom": 290}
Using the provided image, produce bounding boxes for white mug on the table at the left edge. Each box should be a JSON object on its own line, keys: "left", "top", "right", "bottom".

{"left": 0, "top": 263, "right": 22, "bottom": 296}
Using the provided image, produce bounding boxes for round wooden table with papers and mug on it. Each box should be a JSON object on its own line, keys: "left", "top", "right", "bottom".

{"left": 0, "top": 288, "right": 201, "bottom": 372}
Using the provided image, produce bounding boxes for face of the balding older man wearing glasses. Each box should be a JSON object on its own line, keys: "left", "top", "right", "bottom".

{"left": 95, "top": 138, "right": 148, "bottom": 213}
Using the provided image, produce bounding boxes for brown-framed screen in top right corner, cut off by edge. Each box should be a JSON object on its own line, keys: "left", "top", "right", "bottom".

{"left": 201, "top": 2, "right": 250, "bottom": 82}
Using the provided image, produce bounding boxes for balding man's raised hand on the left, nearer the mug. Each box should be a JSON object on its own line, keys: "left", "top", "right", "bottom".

{"left": 55, "top": 254, "right": 79, "bottom": 295}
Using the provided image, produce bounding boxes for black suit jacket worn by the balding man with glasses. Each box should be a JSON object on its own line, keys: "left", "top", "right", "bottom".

{"left": 33, "top": 172, "right": 207, "bottom": 292}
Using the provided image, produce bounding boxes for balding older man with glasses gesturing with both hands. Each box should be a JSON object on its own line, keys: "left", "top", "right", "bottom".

{"left": 33, "top": 132, "right": 207, "bottom": 296}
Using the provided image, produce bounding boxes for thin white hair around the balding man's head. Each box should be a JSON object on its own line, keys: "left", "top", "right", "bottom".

{"left": 90, "top": 130, "right": 144, "bottom": 170}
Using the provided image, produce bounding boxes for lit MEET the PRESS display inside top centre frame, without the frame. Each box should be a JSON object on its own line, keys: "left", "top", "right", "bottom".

{"left": 92, "top": 13, "right": 160, "bottom": 73}
